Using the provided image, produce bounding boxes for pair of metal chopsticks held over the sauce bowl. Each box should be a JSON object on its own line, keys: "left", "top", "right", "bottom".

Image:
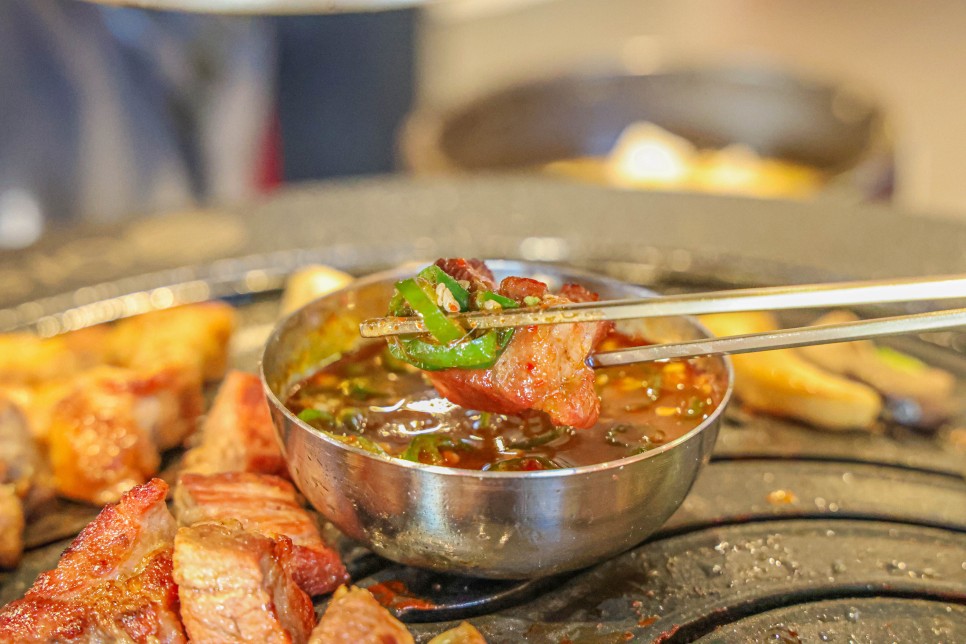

{"left": 359, "top": 275, "right": 966, "bottom": 367}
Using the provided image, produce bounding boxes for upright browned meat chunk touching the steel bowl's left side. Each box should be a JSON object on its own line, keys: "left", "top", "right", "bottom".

{"left": 183, "top": 371, "right": 288, "bottom": 477}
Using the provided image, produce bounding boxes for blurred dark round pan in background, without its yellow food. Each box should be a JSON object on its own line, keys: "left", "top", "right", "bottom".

{"left": 399, "top": 66, "right": 893, "bottom": 199}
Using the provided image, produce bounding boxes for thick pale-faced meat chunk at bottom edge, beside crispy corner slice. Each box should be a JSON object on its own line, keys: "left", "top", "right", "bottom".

{"left": 174, "top": 523, "right": 315, "bottom": 643}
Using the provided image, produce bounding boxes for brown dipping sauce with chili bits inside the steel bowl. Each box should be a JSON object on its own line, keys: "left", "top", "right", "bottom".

{"left": 286, "top": 333, "right": 727, "bottom": 471}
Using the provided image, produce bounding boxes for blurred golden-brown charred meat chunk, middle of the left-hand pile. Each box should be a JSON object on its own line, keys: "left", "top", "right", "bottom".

{"left": 47, "top": 367, "right": 203, "bottom": 504}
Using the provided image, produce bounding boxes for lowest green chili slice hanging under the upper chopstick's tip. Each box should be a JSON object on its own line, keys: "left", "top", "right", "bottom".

{"left": 389, "top": 329, "right": 513, "bottom": 371}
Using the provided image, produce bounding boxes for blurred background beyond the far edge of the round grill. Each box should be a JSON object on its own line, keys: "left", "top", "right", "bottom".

{"left": 0, "top": 0, "right": 966, "bottom": 249}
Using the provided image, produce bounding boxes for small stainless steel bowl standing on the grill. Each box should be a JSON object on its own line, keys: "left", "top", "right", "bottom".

{"left": 262, "top": 261, "right": 732, "bottom": 578}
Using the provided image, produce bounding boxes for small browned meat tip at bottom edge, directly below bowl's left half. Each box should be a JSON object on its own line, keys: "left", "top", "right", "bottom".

{"left": 309, "top": 586, "right": 413, "bottom": 644}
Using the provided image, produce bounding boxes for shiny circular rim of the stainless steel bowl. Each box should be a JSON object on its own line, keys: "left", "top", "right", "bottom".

{"left": 258, "top": 259, "right": 735, "bottom": 479}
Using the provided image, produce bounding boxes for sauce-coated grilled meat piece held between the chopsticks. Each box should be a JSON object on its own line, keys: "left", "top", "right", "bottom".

{"left": 426, "top": 260, "right": 611, "bottom": 428}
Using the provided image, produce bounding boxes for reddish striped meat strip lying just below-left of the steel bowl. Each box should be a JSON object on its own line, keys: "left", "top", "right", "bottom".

{"left": 174, "top": 472, "right": 348, "bottom": 595}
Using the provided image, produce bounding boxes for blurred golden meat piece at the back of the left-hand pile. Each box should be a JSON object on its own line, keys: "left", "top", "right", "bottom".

{"left": 111, "top": 302, "right": 235, "bottom": 380}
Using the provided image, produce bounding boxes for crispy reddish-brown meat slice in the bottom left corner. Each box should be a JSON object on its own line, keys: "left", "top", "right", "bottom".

{"left": 0, "top": 479, "right": 185, "bottom": 642}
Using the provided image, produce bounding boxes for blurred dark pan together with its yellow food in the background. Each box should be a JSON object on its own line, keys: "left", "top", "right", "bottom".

{"left": 400, "top": 69, "right": 893, "bottom": 199}
